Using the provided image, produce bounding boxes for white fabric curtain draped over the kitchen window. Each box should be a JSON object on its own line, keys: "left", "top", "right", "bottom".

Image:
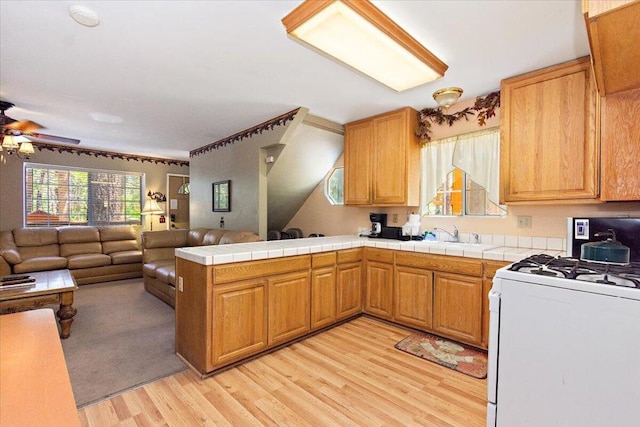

{"left": 420, "top": 128, "right": 500, "bottom": 214}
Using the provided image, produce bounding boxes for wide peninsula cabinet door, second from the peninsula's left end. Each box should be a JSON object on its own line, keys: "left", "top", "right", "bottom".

{"left": 267, "top": 271, "right": 311, "bottom": 345}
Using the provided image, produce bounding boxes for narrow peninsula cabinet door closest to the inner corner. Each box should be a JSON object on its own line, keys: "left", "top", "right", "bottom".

{"left": 336, "top": 261, "right": 362, "bottom": 320}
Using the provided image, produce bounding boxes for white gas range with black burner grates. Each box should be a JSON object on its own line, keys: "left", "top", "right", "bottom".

{"left": 487, "top": 217, "right": 640, "bottom": 427}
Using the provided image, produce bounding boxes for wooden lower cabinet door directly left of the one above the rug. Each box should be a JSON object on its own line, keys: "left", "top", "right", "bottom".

{"left": 393, "top": 265, "right": 433, "bottom": 330}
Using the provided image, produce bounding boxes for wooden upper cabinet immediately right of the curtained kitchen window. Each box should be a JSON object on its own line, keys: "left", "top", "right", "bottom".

{"left": 500, "top": 57, "right": 599, "bottom": 203}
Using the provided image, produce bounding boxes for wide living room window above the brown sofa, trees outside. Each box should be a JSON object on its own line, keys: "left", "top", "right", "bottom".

{"left": 24, "top": 163, "right": 144, "bottom": 227}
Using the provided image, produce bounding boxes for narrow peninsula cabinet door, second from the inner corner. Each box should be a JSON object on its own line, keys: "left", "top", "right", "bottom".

{"left": 311, "top": 266, "right": 336, "bottom": 329}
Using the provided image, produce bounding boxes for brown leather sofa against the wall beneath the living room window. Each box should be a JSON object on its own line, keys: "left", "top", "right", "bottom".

{"left": 0, "top": 226, "right": 142, "bottom": 285}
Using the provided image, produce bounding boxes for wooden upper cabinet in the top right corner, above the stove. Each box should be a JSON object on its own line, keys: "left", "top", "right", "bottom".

{"left": 582, "top": 0, "right": 640, "bottom": 96}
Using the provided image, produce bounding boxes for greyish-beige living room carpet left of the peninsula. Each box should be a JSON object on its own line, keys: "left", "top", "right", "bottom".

{"left": 62, "top": 279, "right": 186, "bottom": 408}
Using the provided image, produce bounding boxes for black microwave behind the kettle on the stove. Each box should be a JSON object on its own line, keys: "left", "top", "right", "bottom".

{"left": 567, "top": 217, "right": 640, "bottom": 263}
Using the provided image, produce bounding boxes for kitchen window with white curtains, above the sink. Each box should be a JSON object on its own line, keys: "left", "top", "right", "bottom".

{"left": 421, "top": 128, "right": 506, "bottom": 215}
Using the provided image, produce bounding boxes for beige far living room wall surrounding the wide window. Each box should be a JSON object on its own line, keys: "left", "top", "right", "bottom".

{"left": 0, "top": 150, "right": 189, "bottom": 230}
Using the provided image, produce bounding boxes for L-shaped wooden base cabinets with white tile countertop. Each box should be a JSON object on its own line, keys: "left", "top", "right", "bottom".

{"left": 176, "top": 236, "right": 563, "bottom": 376}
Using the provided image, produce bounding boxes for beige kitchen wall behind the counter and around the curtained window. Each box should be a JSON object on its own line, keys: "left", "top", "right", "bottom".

{"left": 287, "top": 101, "right": 640, "bottom": 241}
